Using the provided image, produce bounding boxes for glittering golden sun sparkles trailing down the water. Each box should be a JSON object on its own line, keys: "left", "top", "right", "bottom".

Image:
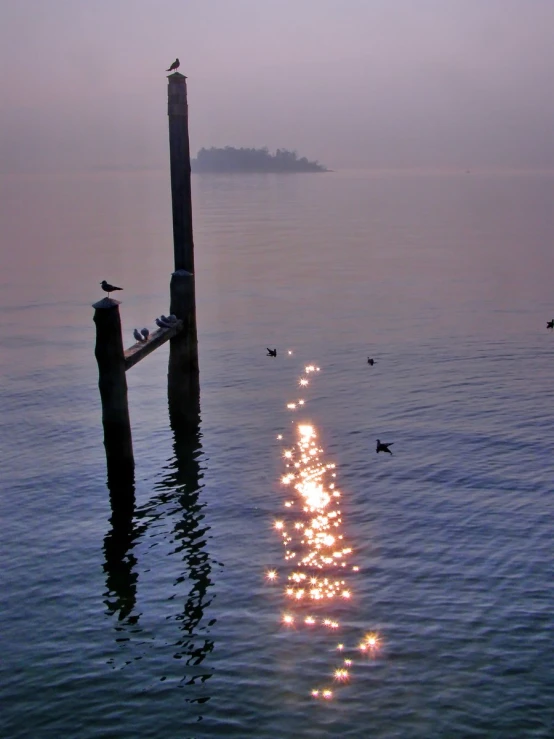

{"left": 265, "top": 364, "right": 380, "bottom": 700}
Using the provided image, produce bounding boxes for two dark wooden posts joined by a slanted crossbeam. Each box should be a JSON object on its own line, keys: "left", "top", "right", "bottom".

{"left": 93, "top": 66, "right": 199, "bottom": 476}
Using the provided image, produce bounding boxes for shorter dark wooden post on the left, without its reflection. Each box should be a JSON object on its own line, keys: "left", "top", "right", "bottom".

{"left": 92, "top": 298, "right": 135, "bottom": 482}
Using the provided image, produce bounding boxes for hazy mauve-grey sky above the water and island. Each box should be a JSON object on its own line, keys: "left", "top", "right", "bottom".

{"left": 0, "top": 0, "right": 554, "bottom": 172}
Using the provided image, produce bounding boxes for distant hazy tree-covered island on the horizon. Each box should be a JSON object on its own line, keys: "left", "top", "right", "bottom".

{"left": 191, "top": 146, "right": 329, "bottom": 172}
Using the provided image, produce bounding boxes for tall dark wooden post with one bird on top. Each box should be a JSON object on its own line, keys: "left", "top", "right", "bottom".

{"left": 167, "top": 72, "right": 198, "bottom": 396}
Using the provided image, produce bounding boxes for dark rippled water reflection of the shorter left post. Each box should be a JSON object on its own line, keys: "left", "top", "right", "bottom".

{"left": 104, "top": 468, "right": 141, "bottom": 623}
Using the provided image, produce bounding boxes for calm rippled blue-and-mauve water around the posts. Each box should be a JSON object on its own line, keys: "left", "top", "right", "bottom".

{"left": 0, "top": 172, "right": 554, "bottom": 739}
